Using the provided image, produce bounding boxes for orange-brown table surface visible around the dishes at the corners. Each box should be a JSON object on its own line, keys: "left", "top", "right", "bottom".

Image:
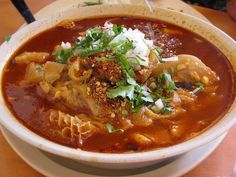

{"left": 0, "top": 0, "right": 236, "bottom": 177}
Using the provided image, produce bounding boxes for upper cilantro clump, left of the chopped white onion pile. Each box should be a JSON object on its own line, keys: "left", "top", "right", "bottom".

{"left": 53, "top": 25, "right": 130, "bottom": 62}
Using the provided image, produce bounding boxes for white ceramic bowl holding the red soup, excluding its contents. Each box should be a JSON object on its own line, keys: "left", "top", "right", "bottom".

{"left": 0, "top": 5, "right": 236, "bottom": 169}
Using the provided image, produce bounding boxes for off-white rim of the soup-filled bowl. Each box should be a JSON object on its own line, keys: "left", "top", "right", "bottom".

{"left": 0, "top": 4, "right": 236, "bottom": 163}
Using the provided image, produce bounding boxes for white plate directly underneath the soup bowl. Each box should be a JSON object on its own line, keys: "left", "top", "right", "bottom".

{"left": 1, "top": 127, "right": 226, "bottom": 177}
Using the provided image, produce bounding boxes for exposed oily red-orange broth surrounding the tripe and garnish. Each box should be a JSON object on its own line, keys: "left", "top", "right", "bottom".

{"left": 2, "top": 17, "right": 233, "bottom": 152}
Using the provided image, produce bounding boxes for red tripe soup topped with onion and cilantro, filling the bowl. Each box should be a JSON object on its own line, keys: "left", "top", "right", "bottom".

{"left": 2, "top": 17, "right": 234, "bottom": 153}
